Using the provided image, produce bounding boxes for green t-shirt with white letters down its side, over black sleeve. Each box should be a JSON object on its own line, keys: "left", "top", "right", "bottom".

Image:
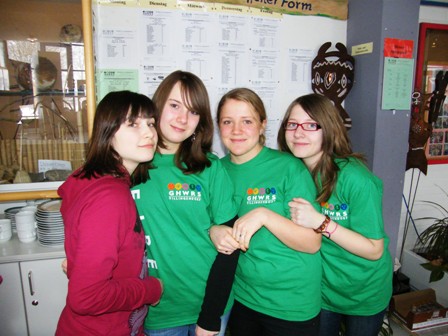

{"left": 132, "top": 154, "right": 237, "bottom": 329}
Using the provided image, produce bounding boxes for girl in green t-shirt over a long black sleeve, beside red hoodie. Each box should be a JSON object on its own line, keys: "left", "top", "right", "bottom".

{"left": 132, "top": 71, "right": 237, "bottom": 336}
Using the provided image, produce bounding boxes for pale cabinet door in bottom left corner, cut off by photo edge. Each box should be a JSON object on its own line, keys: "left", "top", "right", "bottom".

{"left": 0, "top": 263, "right": 27, "bottom": 335}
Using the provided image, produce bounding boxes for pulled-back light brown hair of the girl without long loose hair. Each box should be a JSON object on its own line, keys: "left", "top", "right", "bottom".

{"left": 216, "top": 88, "right": 267, "bottom": 146}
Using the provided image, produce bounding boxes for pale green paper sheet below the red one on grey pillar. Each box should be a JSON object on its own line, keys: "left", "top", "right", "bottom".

{"left": 381, "top": 57, "right": 414, "bottom": 110}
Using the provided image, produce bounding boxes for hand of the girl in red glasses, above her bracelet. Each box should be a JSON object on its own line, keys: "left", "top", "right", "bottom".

{"left": 288, "top": 198, "right": 325, "bottom": 229}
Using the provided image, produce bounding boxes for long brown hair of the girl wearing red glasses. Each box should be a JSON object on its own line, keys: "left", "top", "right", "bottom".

{"left": 277, "top": 93, "right": 364, "bottom": 202}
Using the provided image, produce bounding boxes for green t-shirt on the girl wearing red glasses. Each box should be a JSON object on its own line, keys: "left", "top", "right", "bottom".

{"left": 321, "top": 159, "right": 393, "bottom": 316}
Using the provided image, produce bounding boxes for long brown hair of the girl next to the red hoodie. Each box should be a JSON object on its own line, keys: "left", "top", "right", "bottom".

{"left": 153, "top": 70, "right": 213, "bottom": 174}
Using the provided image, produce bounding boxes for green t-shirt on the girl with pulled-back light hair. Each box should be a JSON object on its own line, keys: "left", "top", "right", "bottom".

{"left": 221, "top": 147, "right": 322, "bottom": 321}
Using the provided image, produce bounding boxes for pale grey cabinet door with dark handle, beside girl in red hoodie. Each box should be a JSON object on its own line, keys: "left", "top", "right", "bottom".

{"left": 20, "top": 258, "right": 68, "bottom": 336}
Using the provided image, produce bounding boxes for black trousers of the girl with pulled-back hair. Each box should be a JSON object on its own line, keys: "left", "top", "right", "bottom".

{"left": 229, "top": 301, "right": 319, "bottom": 336}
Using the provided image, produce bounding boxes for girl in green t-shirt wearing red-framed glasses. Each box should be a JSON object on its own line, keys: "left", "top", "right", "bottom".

{"left": 278, "top": 94, "right": 393, "bottom": 336}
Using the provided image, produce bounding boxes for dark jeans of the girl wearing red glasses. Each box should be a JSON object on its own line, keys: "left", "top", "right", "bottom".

{"left": 319, "top": 309, "right": 386, "bottom": 336}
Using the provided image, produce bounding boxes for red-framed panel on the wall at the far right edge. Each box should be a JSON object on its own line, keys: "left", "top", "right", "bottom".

{"left": 414, "top": 23, "right": 448, "bottom": 164}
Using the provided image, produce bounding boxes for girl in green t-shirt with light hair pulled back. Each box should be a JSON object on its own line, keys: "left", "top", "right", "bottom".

{"left": 206, "top": 88, "right": 321, "bottom": 336}
